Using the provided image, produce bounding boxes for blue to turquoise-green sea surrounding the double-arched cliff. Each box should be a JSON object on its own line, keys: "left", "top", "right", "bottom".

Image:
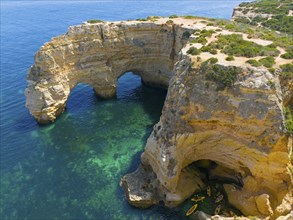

{"left": 0, "top": 0, "right": 249, "bottom": 219}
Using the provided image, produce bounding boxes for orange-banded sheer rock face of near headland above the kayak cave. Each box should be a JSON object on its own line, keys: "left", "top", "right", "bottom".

{"left": 124, "top": 51, "right": 292, "bottom": 218}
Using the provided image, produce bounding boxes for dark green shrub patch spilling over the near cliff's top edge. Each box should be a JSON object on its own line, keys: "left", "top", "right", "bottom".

{"left": 200, "top": 58, "right": 241, "bottom": 90}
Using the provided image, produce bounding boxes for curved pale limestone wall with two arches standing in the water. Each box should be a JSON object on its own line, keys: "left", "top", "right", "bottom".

{"left": 26, "top": 23, "right": 192, "bottom": 123}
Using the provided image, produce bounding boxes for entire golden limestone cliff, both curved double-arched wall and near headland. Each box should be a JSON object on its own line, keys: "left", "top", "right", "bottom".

{"left": 26, "top": 18, "right": 293, "bottom": 218}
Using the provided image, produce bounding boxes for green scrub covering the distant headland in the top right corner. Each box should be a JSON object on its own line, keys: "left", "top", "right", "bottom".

{"left": 235, "top": 0, "right": 293, "bottom": 35}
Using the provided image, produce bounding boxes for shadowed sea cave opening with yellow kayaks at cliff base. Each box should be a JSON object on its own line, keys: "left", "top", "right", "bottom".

{"left": 181, "top": 159, "right": 243, "bottom": 219}
